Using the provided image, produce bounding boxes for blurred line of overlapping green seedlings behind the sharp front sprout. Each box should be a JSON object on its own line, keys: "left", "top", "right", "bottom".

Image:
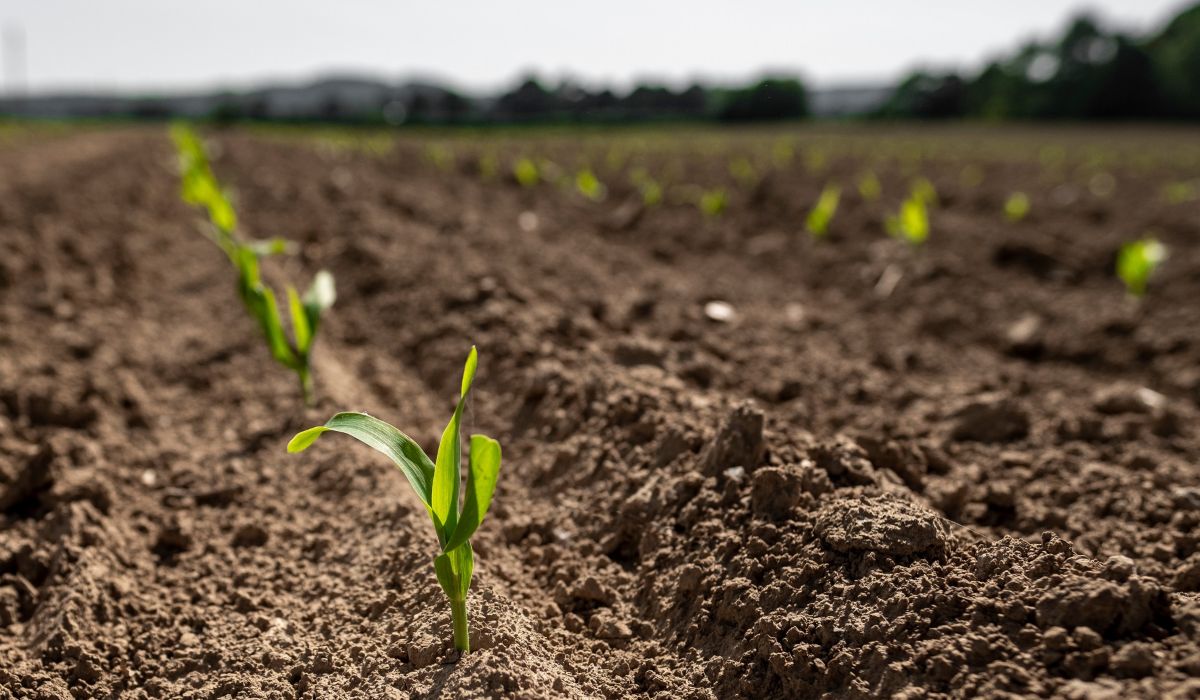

{"left": 170, "top": 125, "right": 336, "bottom": 405}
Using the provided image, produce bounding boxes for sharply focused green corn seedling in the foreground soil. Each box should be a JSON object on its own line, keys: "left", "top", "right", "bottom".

{"left": 288, "top": 346, "right": 500, "bottom": 653}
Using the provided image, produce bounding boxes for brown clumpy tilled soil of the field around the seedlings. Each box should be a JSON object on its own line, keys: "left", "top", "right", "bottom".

{"left": 0, "top": 130, "right": 1200, "bottom": 699}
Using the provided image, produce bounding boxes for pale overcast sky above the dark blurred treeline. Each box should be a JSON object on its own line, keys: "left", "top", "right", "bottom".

{"left": 0, "top": 0, "right": 1186, "bottom": 91}
